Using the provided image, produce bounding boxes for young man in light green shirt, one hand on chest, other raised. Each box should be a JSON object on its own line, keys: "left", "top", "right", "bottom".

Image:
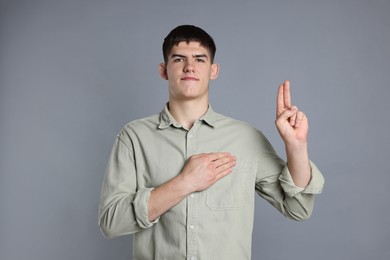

{"left": 99, "top": 25, "right": 324, "bottom": 260}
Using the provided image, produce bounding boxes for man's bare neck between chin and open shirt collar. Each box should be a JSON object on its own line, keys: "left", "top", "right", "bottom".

{"left": 168, "top": 100, "right": 209, "bottom": 129}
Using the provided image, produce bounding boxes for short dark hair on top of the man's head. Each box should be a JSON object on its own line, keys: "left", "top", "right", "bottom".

{"left": 162, "top": 25, "right": 216, "bottom": 63}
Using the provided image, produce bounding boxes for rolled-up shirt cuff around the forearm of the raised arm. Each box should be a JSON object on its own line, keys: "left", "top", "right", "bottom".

{"left": 279, "top": 161, "right": 325, "bottom": 197}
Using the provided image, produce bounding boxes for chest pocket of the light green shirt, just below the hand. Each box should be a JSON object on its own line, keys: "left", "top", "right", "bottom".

{"left": 206, "top": 162, "right": 254, "bottom": 211}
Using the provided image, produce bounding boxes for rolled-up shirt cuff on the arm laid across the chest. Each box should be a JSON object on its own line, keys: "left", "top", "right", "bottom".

{"left": 133, "top": 188, "right": 160, "bottom": 228}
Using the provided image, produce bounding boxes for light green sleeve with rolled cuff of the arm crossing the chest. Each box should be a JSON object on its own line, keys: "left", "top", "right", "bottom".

{"left": 99, "top": 136, "right": 159, "bottom": 238}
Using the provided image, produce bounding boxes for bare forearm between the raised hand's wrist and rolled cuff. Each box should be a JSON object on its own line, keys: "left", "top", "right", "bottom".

{"left": 286, "top": 143, "right": 311, "bottom": 188}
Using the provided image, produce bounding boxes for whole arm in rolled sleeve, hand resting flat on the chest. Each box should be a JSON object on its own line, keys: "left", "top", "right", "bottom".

{"left": 99, "top": 136, "right": 235, "bottom": 238}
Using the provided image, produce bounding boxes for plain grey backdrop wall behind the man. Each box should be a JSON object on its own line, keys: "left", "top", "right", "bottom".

{"left": 0, "top": 0, "right": 390, "bottom": 260}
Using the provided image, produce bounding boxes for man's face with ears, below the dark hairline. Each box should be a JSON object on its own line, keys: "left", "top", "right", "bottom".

{"left": 160, "top": 42, "right": 219, "bottom": 101}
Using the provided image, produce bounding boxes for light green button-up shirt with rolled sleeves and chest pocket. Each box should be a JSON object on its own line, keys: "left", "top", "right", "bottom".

{"left": 99, "top": 106, "right": 324, "bottom": 260}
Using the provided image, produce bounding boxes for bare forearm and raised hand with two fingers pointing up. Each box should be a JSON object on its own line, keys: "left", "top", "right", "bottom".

{"left": 275, "top": 81, "right": 311, "bottom": 188}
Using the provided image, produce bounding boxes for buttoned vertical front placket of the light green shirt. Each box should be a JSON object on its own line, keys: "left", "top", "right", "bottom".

{"left": 186, "top": 122, "right": 198, "bottom": 260}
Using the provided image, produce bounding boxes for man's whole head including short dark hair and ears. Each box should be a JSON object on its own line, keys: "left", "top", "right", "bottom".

{"left": 159, "top": 25, "right": 219, "bottom": 104}
